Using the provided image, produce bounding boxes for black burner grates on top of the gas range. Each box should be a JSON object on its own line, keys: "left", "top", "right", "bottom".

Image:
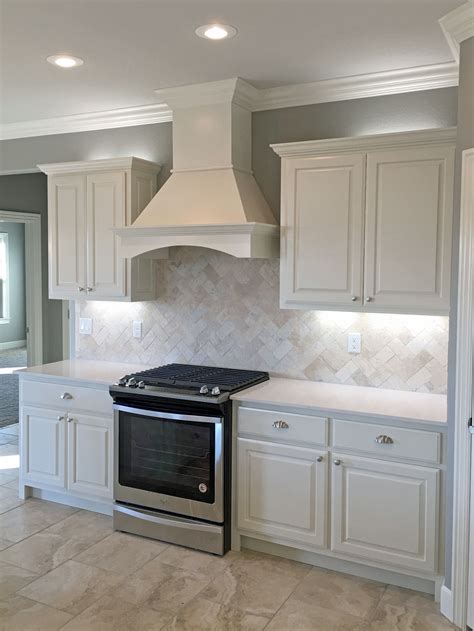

{"left": 124, "top": 364, "right": 269, "bottom": 392}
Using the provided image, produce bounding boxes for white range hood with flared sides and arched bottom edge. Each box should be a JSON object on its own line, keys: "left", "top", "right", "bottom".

{"left": 115, "top": 79, "right": 280, "bottom": 258}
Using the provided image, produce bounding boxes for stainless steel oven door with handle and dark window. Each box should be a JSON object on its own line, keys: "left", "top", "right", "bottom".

{"left": 114, "top": 404, "right": 224, "bottom": 522}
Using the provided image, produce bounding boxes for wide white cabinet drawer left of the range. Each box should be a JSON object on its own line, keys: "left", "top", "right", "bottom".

{"left": 20, "top": 380, "right": 112, "bottom": 416}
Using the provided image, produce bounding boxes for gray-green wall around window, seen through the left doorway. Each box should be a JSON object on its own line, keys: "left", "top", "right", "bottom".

{"left": 0, "top": 222, "right": 26, "bottom": 343}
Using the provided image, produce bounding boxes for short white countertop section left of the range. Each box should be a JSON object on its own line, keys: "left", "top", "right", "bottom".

{"left": 17, "top": 359, "right": 150, "bottom": 386}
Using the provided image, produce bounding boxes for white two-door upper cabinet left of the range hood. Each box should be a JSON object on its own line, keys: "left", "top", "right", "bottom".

{"left": 39, "top": 158, "right": 161, "bottom": 301}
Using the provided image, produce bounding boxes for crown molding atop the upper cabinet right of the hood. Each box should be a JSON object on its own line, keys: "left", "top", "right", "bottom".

{"left": 270, "top": 127, "right": 456, "bottom": 158}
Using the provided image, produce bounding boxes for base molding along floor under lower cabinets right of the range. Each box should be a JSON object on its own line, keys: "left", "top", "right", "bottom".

{"left": 240, "top": 536, "right": 446, "bottom": 600}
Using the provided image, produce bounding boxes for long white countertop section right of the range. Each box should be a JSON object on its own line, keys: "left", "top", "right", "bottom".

{"left": 232, "top": 378, "right": 447, "bottom": 425}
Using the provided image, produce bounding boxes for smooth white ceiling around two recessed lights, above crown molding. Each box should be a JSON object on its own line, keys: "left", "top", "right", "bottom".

{"left": 0, "top": 0, "right": 464, "bottom": 123}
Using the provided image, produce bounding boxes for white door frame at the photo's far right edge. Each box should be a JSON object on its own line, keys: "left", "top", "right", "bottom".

{"left": 450, "top": 148, "right": 474, "bottom": 629}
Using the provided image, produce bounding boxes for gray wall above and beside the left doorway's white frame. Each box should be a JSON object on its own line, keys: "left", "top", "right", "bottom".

{"left": 0, "top": 173, "right": 62, "bottom": 363}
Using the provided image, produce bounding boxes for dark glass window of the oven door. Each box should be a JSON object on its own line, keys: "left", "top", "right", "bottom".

{"left": 119, "top": 411, "right": 216, "bottom": 504}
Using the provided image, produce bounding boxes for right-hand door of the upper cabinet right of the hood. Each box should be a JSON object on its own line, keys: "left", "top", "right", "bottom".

{"left": 364, "top": 146, "right": 454, "bottom": 313}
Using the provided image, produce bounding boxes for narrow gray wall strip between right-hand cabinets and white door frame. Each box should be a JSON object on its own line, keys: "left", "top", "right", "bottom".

{"left": 446, "top": 37, "right": 474, "bottom": 587}
